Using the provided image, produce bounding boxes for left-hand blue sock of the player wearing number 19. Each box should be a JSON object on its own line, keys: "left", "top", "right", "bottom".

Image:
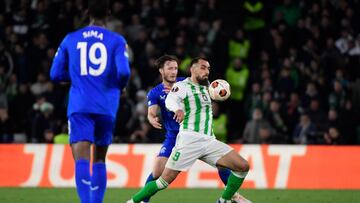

{"left": 75, "top": 159, "right": 91, "bottom": 203}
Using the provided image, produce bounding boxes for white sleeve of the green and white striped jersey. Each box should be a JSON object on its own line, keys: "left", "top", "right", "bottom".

{"left": 165, "top": 82, "right": 186, "bottom": 112}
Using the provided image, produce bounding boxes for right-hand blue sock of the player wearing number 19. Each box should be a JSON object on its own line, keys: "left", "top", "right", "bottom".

{"left": 91, "top": 163, "right": 107, "bottom": 203}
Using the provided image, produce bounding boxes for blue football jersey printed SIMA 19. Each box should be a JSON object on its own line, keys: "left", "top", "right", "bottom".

{"left": 50, "top": 26, "right": 130, "bottom": 118}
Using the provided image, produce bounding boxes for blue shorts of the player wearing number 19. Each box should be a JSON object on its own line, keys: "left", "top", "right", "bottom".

{"left": 68, "top": 113, "right": 115, "bottom": 146}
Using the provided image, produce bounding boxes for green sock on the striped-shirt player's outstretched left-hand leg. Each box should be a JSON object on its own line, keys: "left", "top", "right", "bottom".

{"left": 132, "top": 177, "right": 168, "bottom": 203}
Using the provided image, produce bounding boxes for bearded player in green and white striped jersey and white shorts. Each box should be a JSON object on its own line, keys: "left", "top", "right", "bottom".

{"left": 128, "top": 58, "right": 251, "bottom": 203}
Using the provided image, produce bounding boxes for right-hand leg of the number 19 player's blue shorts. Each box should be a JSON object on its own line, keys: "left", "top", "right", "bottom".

{"left": 93, "top": 114, "right": 115, "bottom": 147}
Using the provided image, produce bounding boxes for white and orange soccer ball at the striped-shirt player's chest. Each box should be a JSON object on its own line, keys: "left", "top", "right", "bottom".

{"left": 209, "top": 79, "right": 231, "bottom": 101}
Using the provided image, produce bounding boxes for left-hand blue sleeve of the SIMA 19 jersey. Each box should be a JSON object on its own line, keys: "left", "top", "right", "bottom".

{"left": 50, "top": 36, "right": 70, "bottom": 82}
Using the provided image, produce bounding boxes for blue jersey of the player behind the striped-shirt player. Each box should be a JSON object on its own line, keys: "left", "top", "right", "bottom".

{"left": 147, "top": 77, "right": 185, "bottom": 136}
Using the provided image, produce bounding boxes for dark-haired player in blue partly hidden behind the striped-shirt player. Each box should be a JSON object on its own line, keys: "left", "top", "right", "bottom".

{"left": 143, "top": 55, "right": 245, "bottom": 202}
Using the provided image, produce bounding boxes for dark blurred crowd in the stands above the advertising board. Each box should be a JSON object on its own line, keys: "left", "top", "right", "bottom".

{"left": 0, "top": 0, "right": 360, "bottom": 144}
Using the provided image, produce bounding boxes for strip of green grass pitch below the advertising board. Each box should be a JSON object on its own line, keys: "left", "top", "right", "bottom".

{"left": 0, "top": 188, "right": 360, "bottom": 203}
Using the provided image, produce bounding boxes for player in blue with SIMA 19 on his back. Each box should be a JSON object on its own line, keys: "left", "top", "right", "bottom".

{"left": 50, "top": 0, "right": 130, "bottom": 203}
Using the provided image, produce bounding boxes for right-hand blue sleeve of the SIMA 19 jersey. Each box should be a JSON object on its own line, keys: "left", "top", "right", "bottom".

{"left": 115, "top": 39, "right": 130, "bottom": 89}
